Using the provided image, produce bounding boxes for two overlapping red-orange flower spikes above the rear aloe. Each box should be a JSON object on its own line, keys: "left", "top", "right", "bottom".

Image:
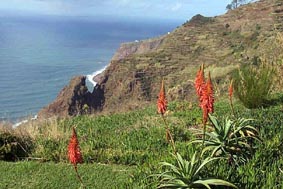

{"left": 195, "top": 65, "right": 214, "bottom": 124}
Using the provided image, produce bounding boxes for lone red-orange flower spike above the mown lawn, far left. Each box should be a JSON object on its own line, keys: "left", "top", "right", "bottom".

{"left": 68, "top": 127, "right": 83, "bottom": 166}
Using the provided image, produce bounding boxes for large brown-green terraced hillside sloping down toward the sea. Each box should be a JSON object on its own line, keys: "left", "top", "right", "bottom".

{"left": 39, "top": 0, "right": 283, "bottom": 118}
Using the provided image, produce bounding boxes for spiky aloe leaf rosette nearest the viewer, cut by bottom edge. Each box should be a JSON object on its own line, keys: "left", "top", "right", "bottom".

{"left": 158, "top": 153, "right": 237, "bottom": 189}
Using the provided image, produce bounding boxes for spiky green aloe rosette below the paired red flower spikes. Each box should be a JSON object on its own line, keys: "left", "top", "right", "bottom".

{"left": 192, "top": 115, "right": 260, "bottom": 162}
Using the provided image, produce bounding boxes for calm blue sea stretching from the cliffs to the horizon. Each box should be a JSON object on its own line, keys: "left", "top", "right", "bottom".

{"left": 0, "top": 16, "right": 180, "bottom": 123}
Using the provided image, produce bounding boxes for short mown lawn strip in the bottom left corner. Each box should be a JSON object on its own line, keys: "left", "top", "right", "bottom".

{"left": 0, "top": 161, "right": 134, "bottom": 189}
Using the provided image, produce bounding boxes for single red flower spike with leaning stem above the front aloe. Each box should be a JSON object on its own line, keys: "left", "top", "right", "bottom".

{"left": 157, "top": 80, "right": 177, "bottom": 154}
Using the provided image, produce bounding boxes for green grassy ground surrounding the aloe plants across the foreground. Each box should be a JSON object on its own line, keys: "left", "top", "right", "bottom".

{"left": 0, "top": 99, "right": 283, "bottom": 188}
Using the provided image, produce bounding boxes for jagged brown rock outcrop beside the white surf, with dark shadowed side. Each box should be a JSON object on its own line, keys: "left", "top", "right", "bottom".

{"left": 38, "top": 76, "right": 104, "bottom": 118}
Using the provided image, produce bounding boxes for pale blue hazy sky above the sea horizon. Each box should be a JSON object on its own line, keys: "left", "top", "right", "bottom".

{"left": 0, "top": 0, "right": 231, "bottom": 20}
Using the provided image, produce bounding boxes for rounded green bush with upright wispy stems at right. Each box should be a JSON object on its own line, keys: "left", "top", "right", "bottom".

{"left": 234, "top": 59, "right": 275, "bottom": 108}
